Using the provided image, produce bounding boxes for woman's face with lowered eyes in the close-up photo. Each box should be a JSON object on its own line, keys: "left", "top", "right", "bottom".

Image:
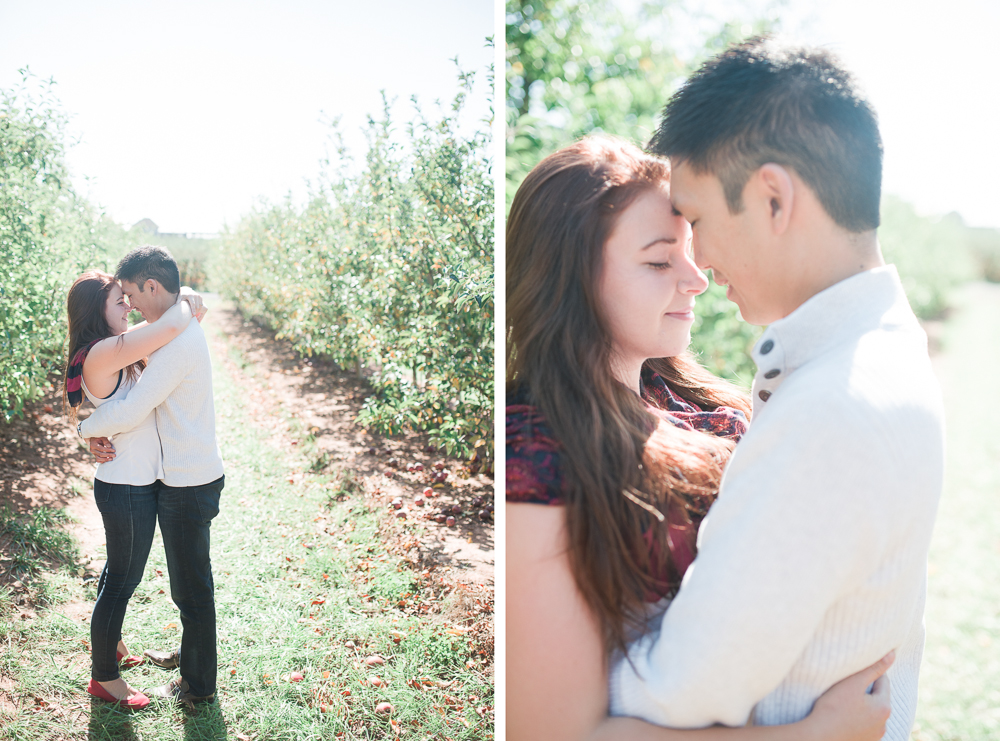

{"left": 598, "top": 186, "right": 708, "bottom": 372}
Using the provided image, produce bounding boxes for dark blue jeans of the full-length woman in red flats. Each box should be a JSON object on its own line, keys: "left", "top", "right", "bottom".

{"left": 90, "top": 479, "right": 160, "bottom": 682}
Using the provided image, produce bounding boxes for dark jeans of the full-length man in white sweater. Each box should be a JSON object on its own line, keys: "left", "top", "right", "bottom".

{"left": 157, "top": 476, "right": 226, "bottom": 697}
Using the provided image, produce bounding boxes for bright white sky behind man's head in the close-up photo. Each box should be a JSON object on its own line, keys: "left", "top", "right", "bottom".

{"left": 672, "top": 0, "right": 1000, "bottom": 227}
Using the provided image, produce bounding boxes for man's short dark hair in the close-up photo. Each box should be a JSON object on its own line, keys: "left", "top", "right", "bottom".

{"left": 650, "top": 37, "right": 882, "bottom": 232}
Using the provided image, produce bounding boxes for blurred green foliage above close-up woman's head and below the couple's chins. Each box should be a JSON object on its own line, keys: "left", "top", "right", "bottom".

{"left": 506, "top": 0, "right": 776, "bottom": 386}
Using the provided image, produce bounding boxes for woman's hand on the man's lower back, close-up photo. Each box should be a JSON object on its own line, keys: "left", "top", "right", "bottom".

{"left": 803, "top": 651, "right": 896, "bottom": 741}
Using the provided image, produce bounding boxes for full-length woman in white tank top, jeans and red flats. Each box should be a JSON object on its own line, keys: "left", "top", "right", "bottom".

{"left": 64, "top": 270, "right": 205, "bottom": 709}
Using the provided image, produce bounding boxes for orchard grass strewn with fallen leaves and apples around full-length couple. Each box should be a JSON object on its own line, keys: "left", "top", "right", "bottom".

{"left": 0, "top": 306, "right": 493, "bottom": 741}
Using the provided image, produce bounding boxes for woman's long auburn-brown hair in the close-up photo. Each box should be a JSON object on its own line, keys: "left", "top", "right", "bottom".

{"left": 506, "top": 137, "right": 750, "bottom": 651}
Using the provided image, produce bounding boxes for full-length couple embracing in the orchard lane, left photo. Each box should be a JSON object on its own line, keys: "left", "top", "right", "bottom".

{"left": 66, "top": 246, "right": 225, "bottom": 709}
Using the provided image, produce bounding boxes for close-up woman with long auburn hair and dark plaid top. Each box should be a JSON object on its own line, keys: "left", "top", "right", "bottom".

{"left": 506, "top": 137, "right": 892, "bottom": 741}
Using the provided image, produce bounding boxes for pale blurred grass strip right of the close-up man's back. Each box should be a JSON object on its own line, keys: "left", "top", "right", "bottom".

{"left": 913, "top": 284, "right": 1000, "bottom": 741}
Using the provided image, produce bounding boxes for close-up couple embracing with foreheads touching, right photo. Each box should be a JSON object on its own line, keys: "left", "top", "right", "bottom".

{"left": 506, "top": 39, "right": 943, "bottom": 741}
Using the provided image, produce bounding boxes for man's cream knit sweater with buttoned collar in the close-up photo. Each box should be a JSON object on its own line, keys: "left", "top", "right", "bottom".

{"left": 610, "top": 265, "right": 944, "bottom": 741}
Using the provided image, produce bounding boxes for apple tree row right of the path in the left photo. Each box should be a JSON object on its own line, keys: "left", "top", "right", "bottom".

{"left": 210, "top": 73, "right": 495, "bottom": 470}
